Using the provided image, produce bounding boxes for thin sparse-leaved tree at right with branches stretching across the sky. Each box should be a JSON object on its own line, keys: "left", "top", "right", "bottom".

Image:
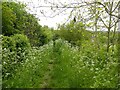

{"left": 32, "top": 0, "right": 120, "bottom": 52}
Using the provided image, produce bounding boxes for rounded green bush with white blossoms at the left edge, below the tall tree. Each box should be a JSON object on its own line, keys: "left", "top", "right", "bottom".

{"left": 2, "top": 34, "right": 30, "bottom": 82}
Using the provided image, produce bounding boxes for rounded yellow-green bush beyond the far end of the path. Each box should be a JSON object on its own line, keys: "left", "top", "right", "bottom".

{"left": 58, "top": 22, "right": 85, "bottom": 46}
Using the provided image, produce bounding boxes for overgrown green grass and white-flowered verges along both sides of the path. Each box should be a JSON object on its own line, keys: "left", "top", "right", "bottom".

{"left": 4, "top": 39, "right": 117, "bottom": 88}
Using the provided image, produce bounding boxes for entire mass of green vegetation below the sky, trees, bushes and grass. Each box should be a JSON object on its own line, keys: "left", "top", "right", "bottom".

{"left": 0, "top": 2, "right": 120, "bottom": 88}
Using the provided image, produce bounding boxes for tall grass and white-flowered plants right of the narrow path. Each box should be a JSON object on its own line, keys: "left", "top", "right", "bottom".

{"left": 51, "top": 40, "right": 117, "bottom": 88}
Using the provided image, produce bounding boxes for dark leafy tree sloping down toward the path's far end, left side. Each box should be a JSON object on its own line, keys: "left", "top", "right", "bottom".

{"left": 23, "top": 14, "right": 43, "bottom": 46}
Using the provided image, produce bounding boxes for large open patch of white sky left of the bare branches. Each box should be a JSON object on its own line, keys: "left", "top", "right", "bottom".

{"left": 17, "top": 0, "right": 74, "bottom": 28}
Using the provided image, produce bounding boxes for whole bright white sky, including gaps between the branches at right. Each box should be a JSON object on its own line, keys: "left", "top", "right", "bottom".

{"left": 13, "top": 0, "right": 119, "bottom": 29}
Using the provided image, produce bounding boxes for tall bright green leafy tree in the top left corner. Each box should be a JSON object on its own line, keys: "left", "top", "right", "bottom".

{"left": 2, "top": 2, "right": 27, "bottom": 36}
